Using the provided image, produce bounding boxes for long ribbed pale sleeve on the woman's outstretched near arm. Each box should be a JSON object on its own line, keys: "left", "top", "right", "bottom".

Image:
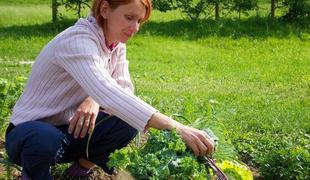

{"left": 55, "top": 29, "right": 157, "bottom": 131}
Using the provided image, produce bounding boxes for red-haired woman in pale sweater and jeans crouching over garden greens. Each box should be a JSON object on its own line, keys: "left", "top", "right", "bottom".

{"left": 6, "top": 0, "right": 214, "bottom": 180}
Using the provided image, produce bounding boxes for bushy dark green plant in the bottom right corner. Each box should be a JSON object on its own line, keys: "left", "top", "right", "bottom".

{"left": 259, "top": 132, "right": 310, "bottom": 179}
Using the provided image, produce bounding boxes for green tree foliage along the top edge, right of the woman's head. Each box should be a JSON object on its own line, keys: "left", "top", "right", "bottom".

{"left": 153, "top": 0, "right": 310, "bottom": 21}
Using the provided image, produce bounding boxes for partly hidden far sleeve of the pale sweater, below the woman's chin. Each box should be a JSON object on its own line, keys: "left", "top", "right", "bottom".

{"left": 112, "top": 45, "right": 134, "bottom": 94}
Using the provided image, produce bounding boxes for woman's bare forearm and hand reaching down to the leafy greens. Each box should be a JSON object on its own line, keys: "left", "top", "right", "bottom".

{"left": 146, "top": 112, "right": 214, "bottom": 156}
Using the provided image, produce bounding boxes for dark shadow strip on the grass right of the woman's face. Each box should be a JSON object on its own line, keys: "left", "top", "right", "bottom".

{"left": 140, "top": 17, "right": 310, "bottom": 40}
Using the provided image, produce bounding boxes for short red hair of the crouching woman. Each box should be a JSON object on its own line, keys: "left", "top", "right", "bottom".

{"left": 91, "top": 0, "right": 152, "bottom": 27}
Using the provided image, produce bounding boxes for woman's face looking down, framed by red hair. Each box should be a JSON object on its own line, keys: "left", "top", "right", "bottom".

{"left": 101, "top": 0, "right": 146, "bottom": 45}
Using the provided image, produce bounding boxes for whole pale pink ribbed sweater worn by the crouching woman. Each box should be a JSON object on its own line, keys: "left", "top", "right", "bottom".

{"left": 11, "top": 16, "right": 157, "bottom": 131}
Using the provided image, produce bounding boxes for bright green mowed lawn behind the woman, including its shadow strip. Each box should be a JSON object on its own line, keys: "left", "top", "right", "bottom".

{"left": 0, "top": 0, "right": 310, "bottom": 176}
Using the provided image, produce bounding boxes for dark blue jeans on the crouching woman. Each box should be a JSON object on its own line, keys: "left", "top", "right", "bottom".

{"left": 5, "top": 112, "right": 137, "bottom": 180}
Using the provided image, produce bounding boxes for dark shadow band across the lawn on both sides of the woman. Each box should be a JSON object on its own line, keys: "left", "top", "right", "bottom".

{"left": 0, "top": 17, "right": 310, "bottom": 40}
